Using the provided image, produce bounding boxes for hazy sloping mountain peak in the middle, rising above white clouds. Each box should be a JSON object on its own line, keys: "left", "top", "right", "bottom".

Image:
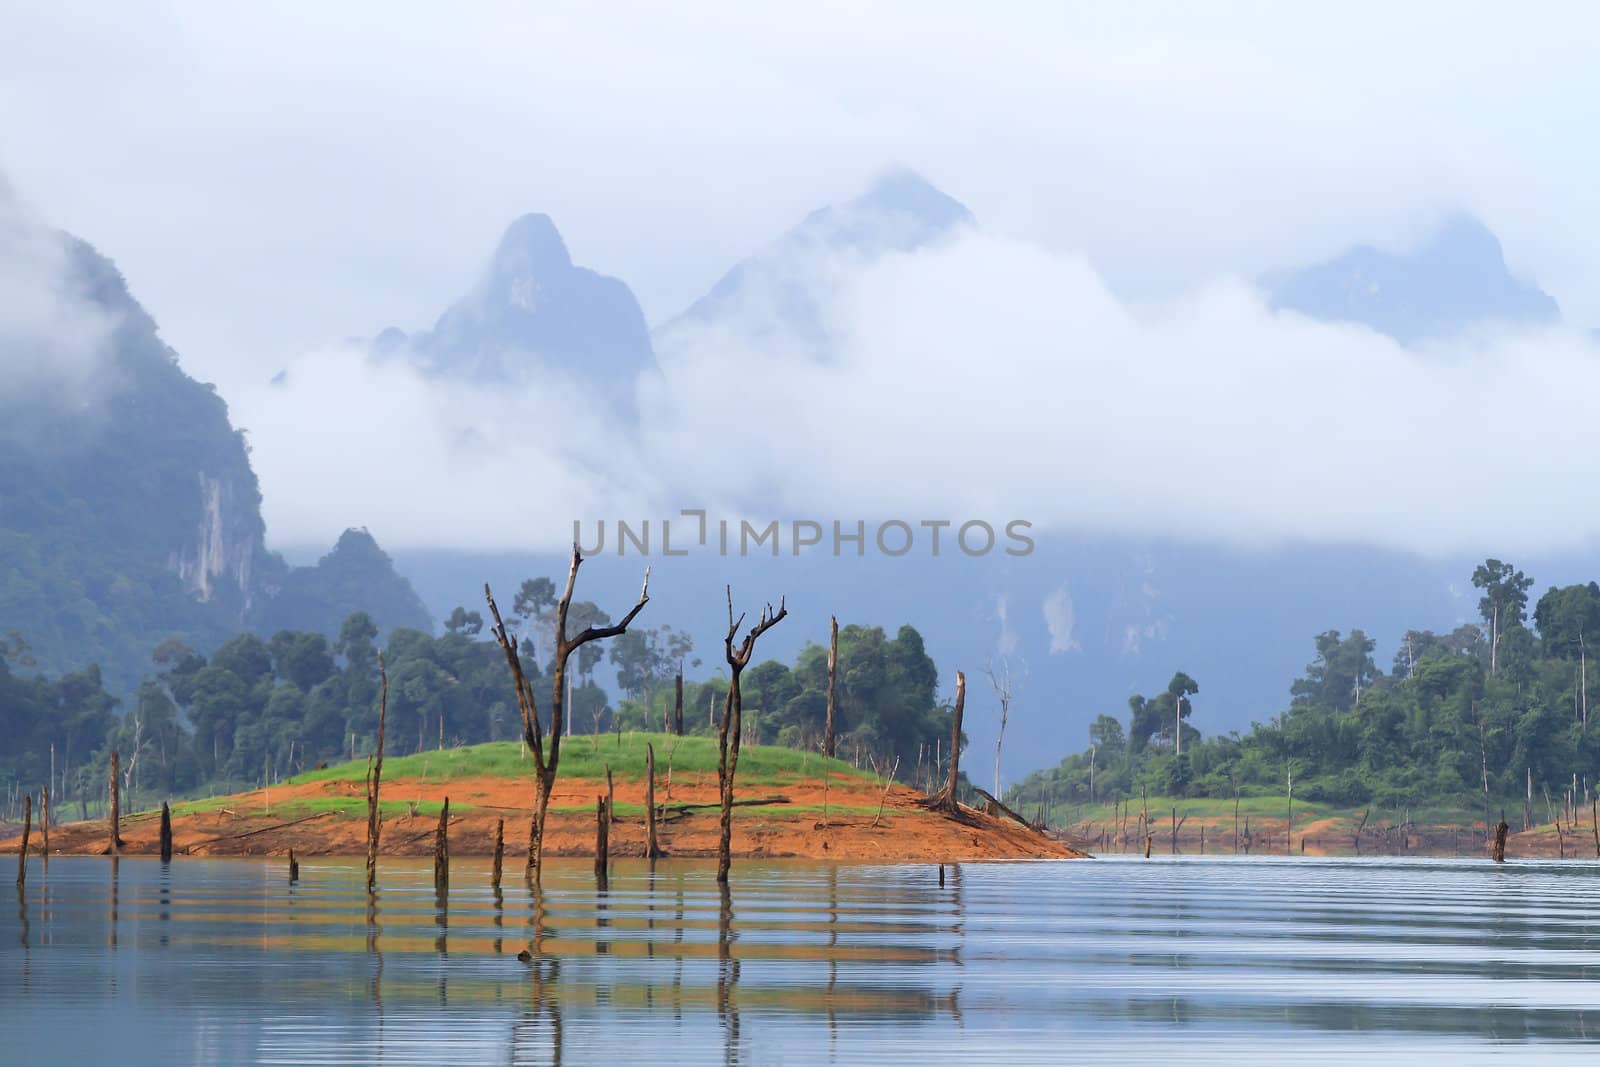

{"left": 656, "top": 171, "right": 974, "bottom": 357}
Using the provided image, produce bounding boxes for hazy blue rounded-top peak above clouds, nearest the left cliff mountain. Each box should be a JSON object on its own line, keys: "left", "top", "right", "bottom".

{"left": 371, "top": 214, "right": 656, "bottom": 410}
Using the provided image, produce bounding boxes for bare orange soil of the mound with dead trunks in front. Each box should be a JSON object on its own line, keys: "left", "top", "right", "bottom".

{"left": 0, "top": 774, "right": 1083, "bottom": 869}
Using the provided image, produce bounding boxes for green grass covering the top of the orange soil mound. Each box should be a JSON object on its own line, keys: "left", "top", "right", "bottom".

{"left": 290, "top": 733, "right": 872, "bottom": 793}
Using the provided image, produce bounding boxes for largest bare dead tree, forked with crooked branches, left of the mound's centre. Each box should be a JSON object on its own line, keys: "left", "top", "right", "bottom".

{"left": 483, "top": 542, "right": 650, "bottom": 878}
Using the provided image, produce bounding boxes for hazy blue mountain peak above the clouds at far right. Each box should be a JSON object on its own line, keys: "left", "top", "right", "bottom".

{"left": 1264, "top": 216, "right": 1562, "bottom": 344}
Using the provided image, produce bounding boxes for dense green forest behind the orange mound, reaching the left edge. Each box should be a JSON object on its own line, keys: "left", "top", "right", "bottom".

{"left": 0, "top": 577, "right": 950, "bottom": 816}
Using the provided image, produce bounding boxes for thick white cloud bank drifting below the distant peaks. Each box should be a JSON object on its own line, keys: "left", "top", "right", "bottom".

{"left": 232, "top": 225, "right": 1600, "bottom": 553}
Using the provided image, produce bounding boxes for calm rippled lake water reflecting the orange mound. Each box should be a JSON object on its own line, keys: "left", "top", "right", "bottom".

{"left": 0, "top": 856, "right": 1600, "bottom": 1067}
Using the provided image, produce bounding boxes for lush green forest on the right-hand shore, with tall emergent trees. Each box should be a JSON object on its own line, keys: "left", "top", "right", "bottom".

{"left": 1006, "top": 560, "right": 1600, "bottom": 821}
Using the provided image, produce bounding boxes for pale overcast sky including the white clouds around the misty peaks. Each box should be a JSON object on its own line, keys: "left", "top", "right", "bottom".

{"left": 0, "top": 3, "right": 1600, "bottom": 553}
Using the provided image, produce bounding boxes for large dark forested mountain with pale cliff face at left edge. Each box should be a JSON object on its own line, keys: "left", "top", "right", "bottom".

{"left": 0, "top": 217, "right": 427, "bottom": 693}
